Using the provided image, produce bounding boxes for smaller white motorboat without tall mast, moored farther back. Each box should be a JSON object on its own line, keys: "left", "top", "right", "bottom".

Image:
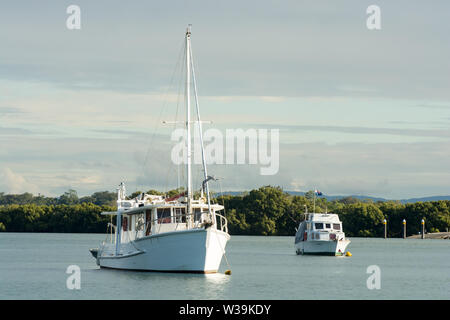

{"left": 295, "top": 213, "right": 350, "bottom": 256}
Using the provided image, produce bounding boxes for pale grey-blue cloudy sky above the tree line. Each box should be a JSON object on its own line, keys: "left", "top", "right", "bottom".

{"left": 0, "top": 0, "right": 450, "bottom": 199}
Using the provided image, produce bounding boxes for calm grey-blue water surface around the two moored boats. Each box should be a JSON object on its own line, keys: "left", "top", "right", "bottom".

{"left": 0, "top": 233, "right": 450, "bottom": 299}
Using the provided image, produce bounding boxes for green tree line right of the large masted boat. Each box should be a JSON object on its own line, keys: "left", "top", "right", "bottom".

{"left": 217, "top": 186, "right": 450, "bottom": 237}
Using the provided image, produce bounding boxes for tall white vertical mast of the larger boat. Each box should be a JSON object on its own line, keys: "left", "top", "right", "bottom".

{"left": 186, "top": 25, "right": 192, "bottom": 215}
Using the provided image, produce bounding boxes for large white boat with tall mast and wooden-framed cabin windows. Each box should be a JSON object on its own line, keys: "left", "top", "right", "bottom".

{"left": 90, "top": 26, "right": 230, "bottom": 273}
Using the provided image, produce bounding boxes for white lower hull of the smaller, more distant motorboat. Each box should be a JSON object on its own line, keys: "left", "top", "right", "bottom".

{"left": 295, "top": 240, "right": 350, "bottom": 256}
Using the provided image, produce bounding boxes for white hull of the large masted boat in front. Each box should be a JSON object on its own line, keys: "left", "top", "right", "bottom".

{"left": 97, "top": 228, "right": 230, "bottom": 273}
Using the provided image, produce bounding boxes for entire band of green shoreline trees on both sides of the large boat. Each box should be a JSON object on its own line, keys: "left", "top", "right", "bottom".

{"left": 0, "top": 186, "right": 450, "bottom": 238}
